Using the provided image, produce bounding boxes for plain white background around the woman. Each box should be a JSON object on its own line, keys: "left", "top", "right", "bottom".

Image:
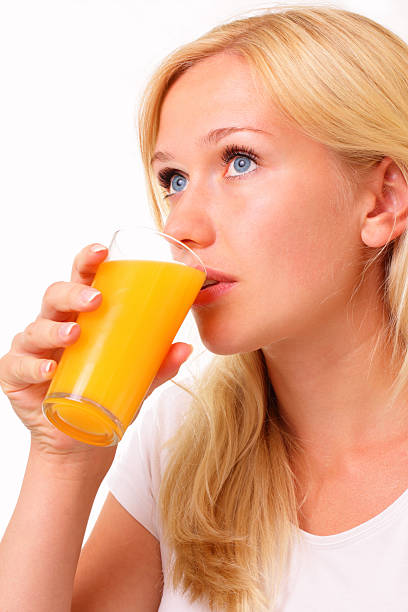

{"left": 0, "top": 0, "right": 408, "bottom": 539}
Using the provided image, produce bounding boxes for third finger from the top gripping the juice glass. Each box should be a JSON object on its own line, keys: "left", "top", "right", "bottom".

{"left": 11, "top": 318, "right": 81, "bottom": 355}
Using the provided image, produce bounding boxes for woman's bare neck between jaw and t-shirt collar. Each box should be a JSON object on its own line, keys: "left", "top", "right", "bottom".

{"left": 262, "top": 280, "right": 408, "bottom": 465}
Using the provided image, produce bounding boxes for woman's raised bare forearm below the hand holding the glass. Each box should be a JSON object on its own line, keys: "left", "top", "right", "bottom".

{"left": 0, "top": 450, "right": 105, "bottom": 612}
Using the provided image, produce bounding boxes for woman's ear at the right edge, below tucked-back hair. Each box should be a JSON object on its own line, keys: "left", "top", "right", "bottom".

{"left": 361, "top": 157, "right": 408, "bottom": 247}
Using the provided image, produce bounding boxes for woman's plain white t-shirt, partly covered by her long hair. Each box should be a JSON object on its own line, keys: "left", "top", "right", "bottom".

{"left": 106, "top": 383, "right": 408, "bottom": 612}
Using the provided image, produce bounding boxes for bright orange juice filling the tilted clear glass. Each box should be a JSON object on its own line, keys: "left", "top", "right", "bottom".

{"left": 43, "top": 260, "right": 205, "bottom": 446}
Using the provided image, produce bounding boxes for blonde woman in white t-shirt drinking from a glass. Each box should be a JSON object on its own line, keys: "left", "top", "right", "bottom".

{"left": 0, "top": 7, "right": 408, "bottom": 612}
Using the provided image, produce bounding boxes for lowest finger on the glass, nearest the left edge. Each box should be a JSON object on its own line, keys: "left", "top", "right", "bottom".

{"left": 0, "top": 353, "right": 57, "bottom": 394}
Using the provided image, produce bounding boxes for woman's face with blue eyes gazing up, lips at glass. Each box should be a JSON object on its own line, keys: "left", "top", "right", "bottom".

{"left": 153, "top": 54, "right": 359, "bottom": 354}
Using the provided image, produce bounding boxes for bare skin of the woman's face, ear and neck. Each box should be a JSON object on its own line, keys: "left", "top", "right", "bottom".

{"left": 153, "top": 54, "right": 408, "bottom": 534}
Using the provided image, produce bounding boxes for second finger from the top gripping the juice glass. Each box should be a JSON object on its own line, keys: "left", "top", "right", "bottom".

{"left": 37, "top": 281, "right": 102, "bottom": 321}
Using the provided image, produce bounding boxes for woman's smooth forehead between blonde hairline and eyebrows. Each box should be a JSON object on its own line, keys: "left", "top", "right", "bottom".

{"left": 152, "top": 53, "right": 338, "bottom": 175}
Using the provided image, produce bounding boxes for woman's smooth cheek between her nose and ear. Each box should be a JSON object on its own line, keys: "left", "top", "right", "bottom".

{"left": 237, "top": 173, "right": 358, "bottom": 314}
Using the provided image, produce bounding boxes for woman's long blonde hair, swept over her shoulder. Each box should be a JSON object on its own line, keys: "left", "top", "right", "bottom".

{"left": 139, "top": 6, "right": 408, "bottom": 612}
